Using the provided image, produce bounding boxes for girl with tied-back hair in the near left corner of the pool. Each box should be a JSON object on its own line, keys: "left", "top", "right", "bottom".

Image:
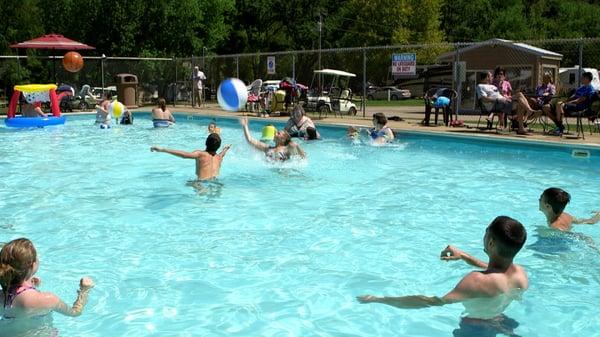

{"left": 0, "top": 238, "right": 94, "bottom": 326}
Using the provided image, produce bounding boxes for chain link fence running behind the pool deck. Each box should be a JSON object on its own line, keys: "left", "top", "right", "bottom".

{"left": 0, "top": 39, "right": 600, "bottom": 113}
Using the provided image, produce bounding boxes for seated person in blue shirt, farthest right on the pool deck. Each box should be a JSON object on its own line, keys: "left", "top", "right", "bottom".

{"left": 549, "top": 72, "right": 595, "bottom": 135}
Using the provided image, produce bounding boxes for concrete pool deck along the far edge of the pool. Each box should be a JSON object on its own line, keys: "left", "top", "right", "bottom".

{"left": 132, "top": 103, "right": 600, "bottom": 149}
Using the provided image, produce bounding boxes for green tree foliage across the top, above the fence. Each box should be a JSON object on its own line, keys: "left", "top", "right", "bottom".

{"left": 0, "top": 0, "right": 600, "bottom": 57}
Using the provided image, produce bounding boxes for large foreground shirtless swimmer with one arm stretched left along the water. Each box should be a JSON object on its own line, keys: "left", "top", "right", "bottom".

{"left": 357, "top": 216, "right": 529, "bottom": 325}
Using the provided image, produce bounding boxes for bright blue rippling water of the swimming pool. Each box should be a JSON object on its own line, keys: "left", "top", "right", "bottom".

{"left": 0, "top": 115, "right": 600, "bottom": 336}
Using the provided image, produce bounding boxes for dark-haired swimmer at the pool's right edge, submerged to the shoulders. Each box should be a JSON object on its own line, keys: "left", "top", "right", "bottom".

{"left": 539, "top": 187, "right": 600, "bottom": 231}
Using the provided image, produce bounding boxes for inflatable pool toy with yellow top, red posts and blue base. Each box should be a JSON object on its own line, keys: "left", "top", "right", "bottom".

{"left": 4, "top": 84, "right": 68, "bottom": 128}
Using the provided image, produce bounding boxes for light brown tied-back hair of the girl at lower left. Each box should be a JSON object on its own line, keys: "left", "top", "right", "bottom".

{"left": 0, "top": 238, "right": 37, "bottom": 305}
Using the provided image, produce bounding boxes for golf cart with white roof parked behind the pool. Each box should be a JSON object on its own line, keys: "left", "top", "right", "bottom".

{"left": 305, "top": 69, "right": 356, "bottom": 117}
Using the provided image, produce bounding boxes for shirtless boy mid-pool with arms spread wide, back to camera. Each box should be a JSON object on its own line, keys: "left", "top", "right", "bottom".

{"left": 150, "top": 133, "right": 231, "bottom": 181}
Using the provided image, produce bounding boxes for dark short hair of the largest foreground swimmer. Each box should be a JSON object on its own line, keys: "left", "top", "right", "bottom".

{"left": 488, "top": 216, "right": 527, "bottom": 259}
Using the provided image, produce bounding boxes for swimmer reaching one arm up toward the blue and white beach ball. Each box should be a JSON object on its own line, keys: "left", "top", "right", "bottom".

{"left": 240, "top": 117, "right": 306, "bottom": 161}
